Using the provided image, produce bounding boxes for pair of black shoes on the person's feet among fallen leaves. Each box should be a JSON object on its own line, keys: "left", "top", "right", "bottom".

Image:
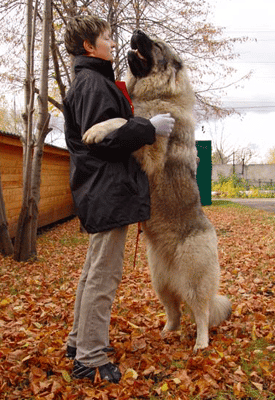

{"left": 72, "top": 360, "right": 121, "bottom": 383}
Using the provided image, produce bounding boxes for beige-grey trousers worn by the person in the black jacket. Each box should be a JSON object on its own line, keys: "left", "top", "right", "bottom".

{"left": 67, "top": 226, "right": 128, "bottom": 367}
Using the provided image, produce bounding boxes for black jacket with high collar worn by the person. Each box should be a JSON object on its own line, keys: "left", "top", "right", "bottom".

{"left": 64, "top": 56, "right": 155, "bottom": 233}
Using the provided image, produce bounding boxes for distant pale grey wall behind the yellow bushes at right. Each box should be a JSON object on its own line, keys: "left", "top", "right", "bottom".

{"left": 212, "top": 164, "right": 275, "bottom": 187}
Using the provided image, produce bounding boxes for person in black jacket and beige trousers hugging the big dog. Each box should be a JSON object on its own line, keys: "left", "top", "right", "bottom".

{"left": 64, "top": 16, "right": 174, "bottom": 383}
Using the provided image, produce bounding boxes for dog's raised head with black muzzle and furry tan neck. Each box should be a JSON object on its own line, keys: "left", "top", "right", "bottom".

{"left": 126, "top": 30, "right": 192, "bottom": 100}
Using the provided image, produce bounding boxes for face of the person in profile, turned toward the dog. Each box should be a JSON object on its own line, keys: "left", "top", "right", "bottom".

{"left": 84, "top": 30, "right": 116, "bottom": 62}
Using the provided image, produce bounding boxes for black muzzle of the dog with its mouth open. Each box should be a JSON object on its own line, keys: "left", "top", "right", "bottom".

{"left": 128, "top": 30, "right": 153, "bottom": 77}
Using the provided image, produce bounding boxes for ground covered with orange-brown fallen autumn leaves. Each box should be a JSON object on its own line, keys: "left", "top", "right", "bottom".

{"left": 0, "top": 201, "right": 275, "bottom": 400}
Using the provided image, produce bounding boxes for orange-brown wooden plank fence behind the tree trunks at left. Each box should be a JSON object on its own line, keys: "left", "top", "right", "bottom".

{"left": 0, "top": 131, "right": 74, "bottom": 237}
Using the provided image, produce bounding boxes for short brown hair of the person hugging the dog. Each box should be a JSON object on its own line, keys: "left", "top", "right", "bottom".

{"left": 64, "top": 15, "right": 111, "bottom": 56}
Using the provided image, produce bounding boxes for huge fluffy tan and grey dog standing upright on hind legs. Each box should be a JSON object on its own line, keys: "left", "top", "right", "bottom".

{"left": 83, "top": 30, "right": 231, "bottom": 352}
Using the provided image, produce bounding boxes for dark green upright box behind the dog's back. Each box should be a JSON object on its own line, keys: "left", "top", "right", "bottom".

{"left": 196, "top": 140, "right": 212, "bottom": 206}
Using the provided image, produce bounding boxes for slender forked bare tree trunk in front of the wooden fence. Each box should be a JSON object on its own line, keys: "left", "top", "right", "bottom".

{"left": 14, "top": 0, "right": 51, "bottom": 261}
